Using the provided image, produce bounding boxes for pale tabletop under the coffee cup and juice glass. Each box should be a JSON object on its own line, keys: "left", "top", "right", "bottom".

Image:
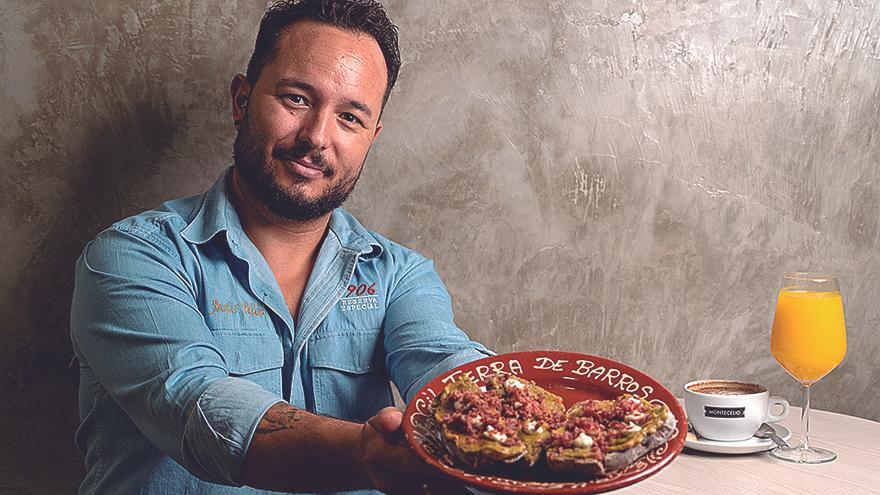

{"left": 612, "top": 407, "right": 880, "bottom": 495}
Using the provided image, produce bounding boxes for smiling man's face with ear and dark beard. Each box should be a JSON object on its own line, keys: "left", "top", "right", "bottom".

{"left": 233, "top": 21, "right": 387, "bottom": 221}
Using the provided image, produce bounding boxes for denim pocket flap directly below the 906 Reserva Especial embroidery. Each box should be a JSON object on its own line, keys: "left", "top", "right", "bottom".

{"left": 309, "top": 329, "right": 385, "bottom": 374}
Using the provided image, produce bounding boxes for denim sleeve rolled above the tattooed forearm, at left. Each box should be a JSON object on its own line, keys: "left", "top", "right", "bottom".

{"left": 71, "top": 229, "right": 281, "bottom": 486}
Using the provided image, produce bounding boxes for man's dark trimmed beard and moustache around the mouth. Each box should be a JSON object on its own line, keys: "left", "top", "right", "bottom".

{"left": 233, "top": 114, "right": 366, "bottom": 222}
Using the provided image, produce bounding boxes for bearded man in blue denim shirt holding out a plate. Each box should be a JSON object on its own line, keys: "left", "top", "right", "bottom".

{"left": 71, "top": 0, "right": 489, "bottom": 494}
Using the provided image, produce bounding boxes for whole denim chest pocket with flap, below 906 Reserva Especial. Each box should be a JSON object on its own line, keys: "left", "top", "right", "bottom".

{"left": 309, "top": 329, "right": 394, "bottom": 422}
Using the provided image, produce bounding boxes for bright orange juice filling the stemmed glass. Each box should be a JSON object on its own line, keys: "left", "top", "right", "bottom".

{"left": 770, "top": 289, "right": 846, "bottom": 385}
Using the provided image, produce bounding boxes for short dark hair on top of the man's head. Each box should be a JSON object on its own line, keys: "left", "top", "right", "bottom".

{"left": 246, "top": 0, "right": 400, "bottom": 107}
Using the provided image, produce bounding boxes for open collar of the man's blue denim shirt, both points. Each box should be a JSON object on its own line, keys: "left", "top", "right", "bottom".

{"left": 180, "top": 167, "right": 382, "bottom": 258}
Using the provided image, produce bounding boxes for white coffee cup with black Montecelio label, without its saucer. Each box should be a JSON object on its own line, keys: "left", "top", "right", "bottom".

{"left": 684, "top": 380, "right": 789, "bottom": 442}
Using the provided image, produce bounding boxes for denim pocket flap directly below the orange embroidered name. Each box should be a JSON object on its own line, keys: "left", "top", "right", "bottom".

{"left": 214, "top": 330, "right": 284, "bottom": 375}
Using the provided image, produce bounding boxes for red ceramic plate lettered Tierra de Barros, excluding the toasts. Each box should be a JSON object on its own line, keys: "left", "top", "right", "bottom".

{"left": 403, "top": 351, "right": 687, "bottom": 495}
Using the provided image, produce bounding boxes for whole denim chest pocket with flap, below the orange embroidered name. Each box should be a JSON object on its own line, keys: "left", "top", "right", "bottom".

{"left": 211, "top": 328, "right": 284, "bottom": 397}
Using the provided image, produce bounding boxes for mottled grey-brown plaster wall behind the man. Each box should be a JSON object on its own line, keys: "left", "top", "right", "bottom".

{"left": 0, "top": 0, "right": 880, "bottom": 493}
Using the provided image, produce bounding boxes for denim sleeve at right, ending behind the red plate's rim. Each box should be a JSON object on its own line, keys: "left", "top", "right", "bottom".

{"left": 384, "top": 259, "right": 494, "bottom": 402}
